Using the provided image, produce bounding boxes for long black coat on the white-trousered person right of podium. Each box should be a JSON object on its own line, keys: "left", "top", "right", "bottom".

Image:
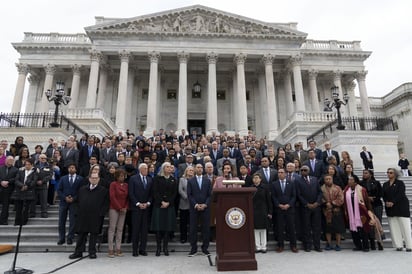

{"left": 253, "top": 184, "right": 272, "bottom": 229}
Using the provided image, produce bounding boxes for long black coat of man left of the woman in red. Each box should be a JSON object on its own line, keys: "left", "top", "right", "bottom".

{"left": 74, "top": 185, "right": 109, "bottom": 233}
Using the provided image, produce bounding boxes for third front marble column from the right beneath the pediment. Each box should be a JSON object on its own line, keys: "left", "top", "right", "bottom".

{"left": 235, "top": 53, "right": 248, "bottom": 136}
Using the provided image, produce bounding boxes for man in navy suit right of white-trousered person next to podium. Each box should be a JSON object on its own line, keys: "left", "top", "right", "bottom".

{"left": 271, "top": 168, "right": 298, "bottom": 253}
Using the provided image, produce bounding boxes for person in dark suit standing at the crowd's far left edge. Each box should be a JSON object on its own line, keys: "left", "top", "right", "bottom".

{"left": 0, "top": 156, "right": 18, "bottom": 225}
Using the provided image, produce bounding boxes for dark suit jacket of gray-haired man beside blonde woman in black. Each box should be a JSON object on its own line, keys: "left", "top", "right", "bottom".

{"left": 129, "top": 173, "right": 153, "bottom": 210}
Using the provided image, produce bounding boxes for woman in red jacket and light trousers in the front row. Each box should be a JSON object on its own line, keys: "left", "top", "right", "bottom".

{"left": 107, "top": 169, "right": 129, "bottom": 258}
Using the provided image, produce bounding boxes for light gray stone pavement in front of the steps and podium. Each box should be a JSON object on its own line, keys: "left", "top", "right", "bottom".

{"left": 0, "top": 248, "right": 412, "bottom": 274}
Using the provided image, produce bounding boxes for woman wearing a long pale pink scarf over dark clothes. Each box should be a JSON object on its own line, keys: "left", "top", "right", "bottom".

{"left": 343, "top": 176, "right": 372, "bottom": 252}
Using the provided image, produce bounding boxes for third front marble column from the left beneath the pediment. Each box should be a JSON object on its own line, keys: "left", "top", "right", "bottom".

{"left": 144, "top": 51, "right": 160, "bottom": 136}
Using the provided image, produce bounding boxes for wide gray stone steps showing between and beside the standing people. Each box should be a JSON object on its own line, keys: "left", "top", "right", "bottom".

{"left": 0, "top": 173, "right": 412, "bottom": 252}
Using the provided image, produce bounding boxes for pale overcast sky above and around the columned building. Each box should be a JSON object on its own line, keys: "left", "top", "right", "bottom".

{"left": 0, "top": 0, "right": 412, "bottom": 112}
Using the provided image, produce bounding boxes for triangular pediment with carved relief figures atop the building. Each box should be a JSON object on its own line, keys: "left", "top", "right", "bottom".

{"left": 86, "top": 5, "right": 306, "bottom": 40}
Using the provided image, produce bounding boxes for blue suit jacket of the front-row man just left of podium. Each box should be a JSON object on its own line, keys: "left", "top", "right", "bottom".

{"left": 187, "top": 176, "right": 212, "bottom": 210}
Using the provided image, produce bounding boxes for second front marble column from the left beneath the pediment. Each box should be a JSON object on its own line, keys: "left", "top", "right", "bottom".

{"left": 116, "top": 50, "right": 131, "bottom": 132}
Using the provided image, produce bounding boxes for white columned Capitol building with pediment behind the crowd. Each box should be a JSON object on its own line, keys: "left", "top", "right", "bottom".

{"left": 4, "top": 5, "right": 412, "bottom": 169}
